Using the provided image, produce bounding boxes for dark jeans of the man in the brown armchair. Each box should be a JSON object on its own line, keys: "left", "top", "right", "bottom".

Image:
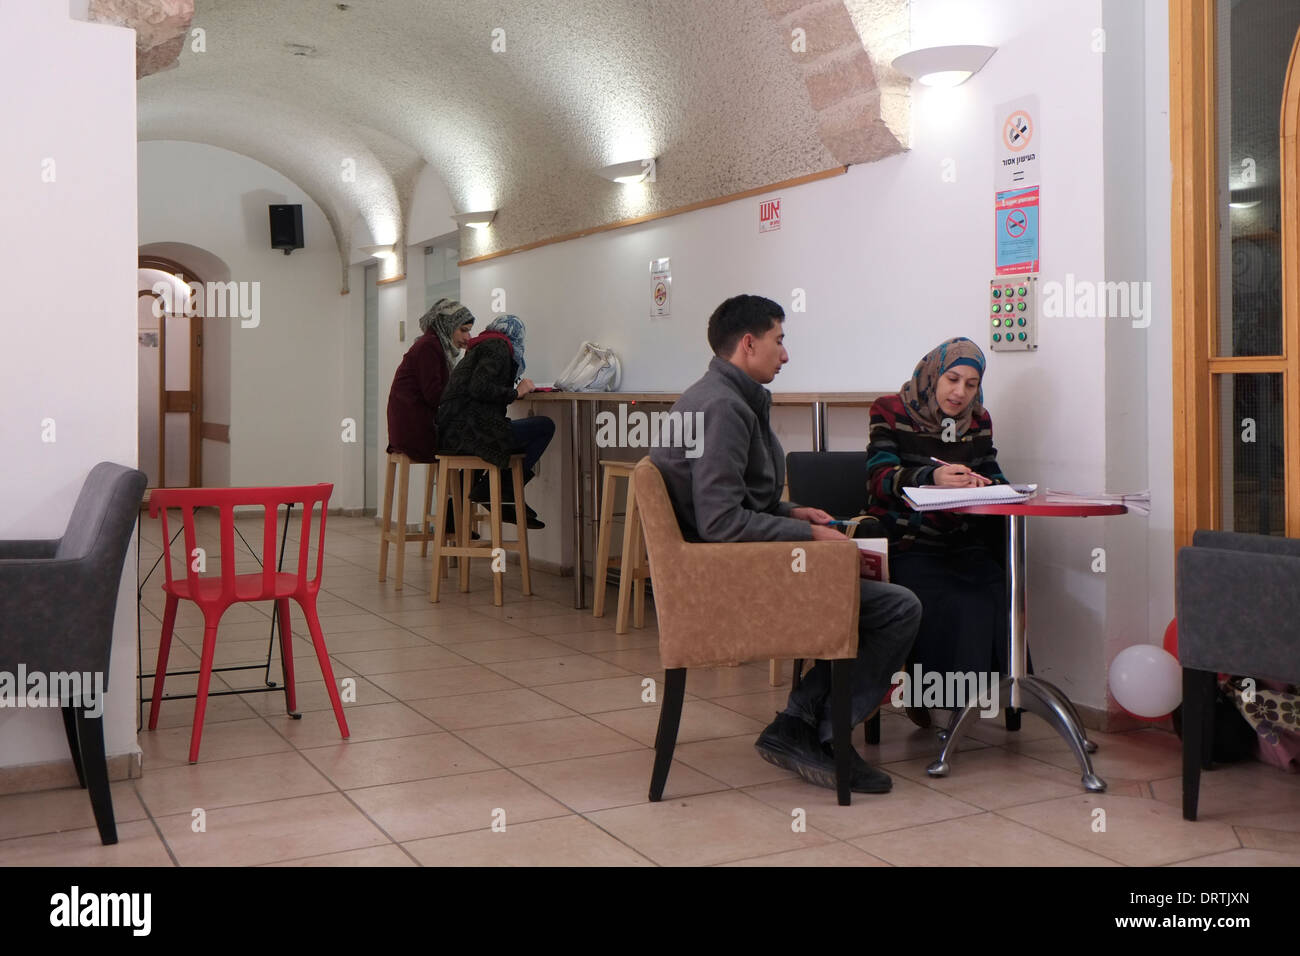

{"left": 783, "top": 581, "right": 920, "bottom": 743}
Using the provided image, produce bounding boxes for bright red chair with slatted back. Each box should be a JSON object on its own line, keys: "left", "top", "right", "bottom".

{"left": 150, "top": 484, "right": 348, "bottom": 763}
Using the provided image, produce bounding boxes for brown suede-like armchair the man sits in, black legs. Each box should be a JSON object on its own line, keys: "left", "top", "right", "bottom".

{"left": 633, "top": 458, "right": 861, "bottom": 806}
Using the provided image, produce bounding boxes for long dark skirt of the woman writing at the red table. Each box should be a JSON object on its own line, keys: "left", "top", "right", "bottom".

{"left": 889, "top": 545, "right": 1008, "bottom": 674}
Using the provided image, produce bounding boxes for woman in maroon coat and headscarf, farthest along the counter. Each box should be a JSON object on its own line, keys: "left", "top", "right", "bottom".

{"left": 389, "top": 299, "right": 475, "bottom": 462}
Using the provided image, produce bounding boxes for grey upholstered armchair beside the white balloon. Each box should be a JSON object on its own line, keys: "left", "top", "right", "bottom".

{"left": 1177, "top": 531, "right": 1300, "bottom": 819}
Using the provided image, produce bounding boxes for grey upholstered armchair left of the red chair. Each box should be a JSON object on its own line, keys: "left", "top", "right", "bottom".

{"left": 0, "top": 462, "right": 146, "bottom": 845}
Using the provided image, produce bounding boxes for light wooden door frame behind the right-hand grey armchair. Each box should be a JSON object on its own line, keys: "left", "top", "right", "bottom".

{"left": 1169, "top": 0, "right": 1300, "bottom": 548}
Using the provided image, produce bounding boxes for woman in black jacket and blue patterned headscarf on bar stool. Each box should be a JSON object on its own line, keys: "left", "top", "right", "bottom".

{"left": 438, "top": 315, "right": 555, "bottom": 528}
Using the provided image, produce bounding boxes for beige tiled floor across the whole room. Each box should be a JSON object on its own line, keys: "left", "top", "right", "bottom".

{"left": 0, "top": 518, "right": 1300, "bottom": 866}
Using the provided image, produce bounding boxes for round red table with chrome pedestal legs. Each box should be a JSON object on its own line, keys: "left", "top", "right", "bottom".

{"left": 926, "top": 496, "right": 1128, "bottom": 792}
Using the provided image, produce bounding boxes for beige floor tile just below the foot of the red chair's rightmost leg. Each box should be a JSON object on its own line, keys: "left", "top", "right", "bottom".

{"left": 302, "top": 734, "right": 495, "bottom": 790}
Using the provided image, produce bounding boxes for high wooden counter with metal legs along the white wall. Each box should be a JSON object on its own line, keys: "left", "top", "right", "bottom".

{"left": 524, "top": 392, "right": 893, "bottom": 609}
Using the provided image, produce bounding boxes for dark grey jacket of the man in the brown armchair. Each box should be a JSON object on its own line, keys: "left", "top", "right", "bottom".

{"left": 650, "top": 355, "right": 813, "bottom": 541}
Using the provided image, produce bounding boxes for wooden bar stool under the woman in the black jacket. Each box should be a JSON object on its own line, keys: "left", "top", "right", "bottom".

{"left": 429, "top": 455, "right": 533, "bottom": 607}
